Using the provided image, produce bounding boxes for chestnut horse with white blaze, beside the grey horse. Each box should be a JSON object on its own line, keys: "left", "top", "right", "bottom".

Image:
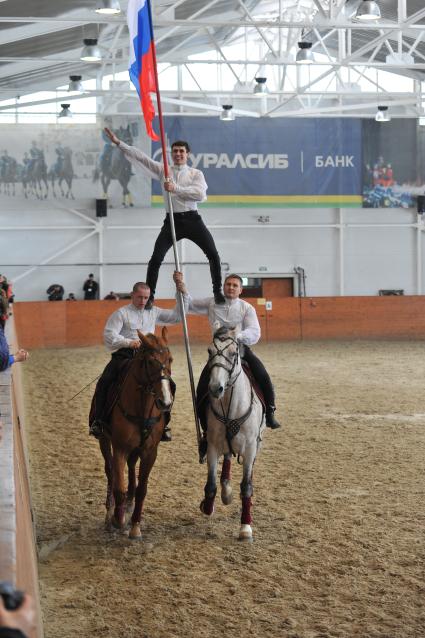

{"left": 99, "top": 327, "right": 173, "bottom": 539}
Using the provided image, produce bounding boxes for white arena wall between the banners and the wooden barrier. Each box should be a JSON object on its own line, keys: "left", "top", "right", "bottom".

{"left": 0, "top": 206, "right": 425, "bottom": 301}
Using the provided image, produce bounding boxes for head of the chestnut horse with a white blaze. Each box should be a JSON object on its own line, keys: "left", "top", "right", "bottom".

{"left": 136, "top": 326, "right": 174, "bottom": 412}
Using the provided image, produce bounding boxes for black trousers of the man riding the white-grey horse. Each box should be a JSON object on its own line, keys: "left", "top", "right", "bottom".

{"left": 196, "top": 346, "right": 275, "bottom": 432}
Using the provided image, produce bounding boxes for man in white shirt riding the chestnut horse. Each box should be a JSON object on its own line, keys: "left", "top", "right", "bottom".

{"left": 90, "top": 273, "right": 188, "bottom": 441}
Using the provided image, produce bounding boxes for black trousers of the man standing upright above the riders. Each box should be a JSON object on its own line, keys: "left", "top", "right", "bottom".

{"left": 146, "top": 210, "right": 221, "bottom": 295}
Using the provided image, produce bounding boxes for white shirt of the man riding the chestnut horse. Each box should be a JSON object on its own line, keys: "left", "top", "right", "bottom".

{"left": 103, "top": 295, "right": 188, "bottom": 352}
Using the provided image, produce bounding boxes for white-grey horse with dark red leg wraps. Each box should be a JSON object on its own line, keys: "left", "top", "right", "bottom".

{"left": 200, "top": 327, "right": 265, "bottom": 541}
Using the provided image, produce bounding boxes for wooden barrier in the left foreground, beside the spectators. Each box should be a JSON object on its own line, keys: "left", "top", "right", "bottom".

{"left": 0, "top": 321, "right": 43, "bottom": 638}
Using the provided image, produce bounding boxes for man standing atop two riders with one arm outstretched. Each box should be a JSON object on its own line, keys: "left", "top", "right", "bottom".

{"left": 105, "top": 128, "right": 225, "bottom": 304}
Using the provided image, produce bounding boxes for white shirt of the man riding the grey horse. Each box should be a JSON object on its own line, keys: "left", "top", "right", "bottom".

{"left": 189, "top": 295, "right": 261, "bottom": 346}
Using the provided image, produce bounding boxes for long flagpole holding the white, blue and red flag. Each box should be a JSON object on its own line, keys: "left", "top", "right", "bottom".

{"left": 146, "top": 0, "right": 202, "bottom": 462}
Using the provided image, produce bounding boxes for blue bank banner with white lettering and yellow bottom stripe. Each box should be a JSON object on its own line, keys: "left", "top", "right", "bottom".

{"left": 152, "top": 117, "right": 362, "bottom": 207}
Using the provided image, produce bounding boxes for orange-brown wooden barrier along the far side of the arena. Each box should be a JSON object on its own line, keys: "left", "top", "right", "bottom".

{"left": 14, "top": 296, "right": 425, "bottom": 349}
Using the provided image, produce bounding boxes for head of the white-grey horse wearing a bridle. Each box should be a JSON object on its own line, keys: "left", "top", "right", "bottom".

{"left": 208, "top": 327, "right": 242, "bottom": 399}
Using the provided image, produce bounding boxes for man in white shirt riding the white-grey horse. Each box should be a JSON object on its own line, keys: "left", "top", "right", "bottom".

{"left": 174, "top": 272, "right": 280, "bottom": 455}
